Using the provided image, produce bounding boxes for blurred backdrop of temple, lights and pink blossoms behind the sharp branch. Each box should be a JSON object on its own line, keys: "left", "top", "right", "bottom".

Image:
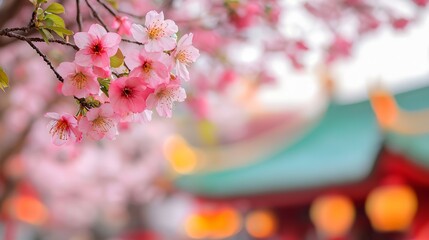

{"left": 0, "top": 0, "right": 429, "bottom": 240}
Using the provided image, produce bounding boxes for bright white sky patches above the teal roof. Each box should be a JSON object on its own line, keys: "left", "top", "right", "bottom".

{"left": 261, "top": 5, "right": 429, "bottom": 107}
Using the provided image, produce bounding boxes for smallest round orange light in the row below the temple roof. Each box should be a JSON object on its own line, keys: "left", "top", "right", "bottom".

{"left": 246, "top": 210, "right": 278, "bottom": 238}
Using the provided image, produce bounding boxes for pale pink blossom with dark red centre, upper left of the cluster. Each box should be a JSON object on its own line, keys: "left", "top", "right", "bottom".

{"left": 74, "top": 24, "right": 121, "bottom": 68}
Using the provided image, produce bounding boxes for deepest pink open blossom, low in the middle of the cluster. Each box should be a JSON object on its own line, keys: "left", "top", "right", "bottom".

{"left": 109, "top": 77, "right": 151, "bottom": 116}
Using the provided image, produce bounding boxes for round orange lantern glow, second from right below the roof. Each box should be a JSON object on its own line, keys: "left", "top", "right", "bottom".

{"left": 310, "top": 195, "right": 355, "bottom": 237}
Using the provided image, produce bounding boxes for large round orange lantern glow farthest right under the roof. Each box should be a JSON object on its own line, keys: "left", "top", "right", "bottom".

{"left": 365, "top": 185, "right": 418, "bottom": 232}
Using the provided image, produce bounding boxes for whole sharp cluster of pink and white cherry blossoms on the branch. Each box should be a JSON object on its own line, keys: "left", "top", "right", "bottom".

{"left": 46, "top": 11, "right": 199, "bottom": 145}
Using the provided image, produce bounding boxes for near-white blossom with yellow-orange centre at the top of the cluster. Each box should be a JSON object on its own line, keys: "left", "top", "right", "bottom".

{"left": 131, "top": 11, "right": 178, "bottom": 52}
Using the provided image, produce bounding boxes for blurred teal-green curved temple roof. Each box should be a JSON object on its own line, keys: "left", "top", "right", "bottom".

{"left": 176, "top": 88, "right": 429, "bottom": 198}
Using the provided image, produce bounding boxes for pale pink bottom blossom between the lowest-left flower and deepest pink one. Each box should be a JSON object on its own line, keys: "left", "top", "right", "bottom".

{"left": 79, "top": 104, "right": 118, "bottom": 140}
